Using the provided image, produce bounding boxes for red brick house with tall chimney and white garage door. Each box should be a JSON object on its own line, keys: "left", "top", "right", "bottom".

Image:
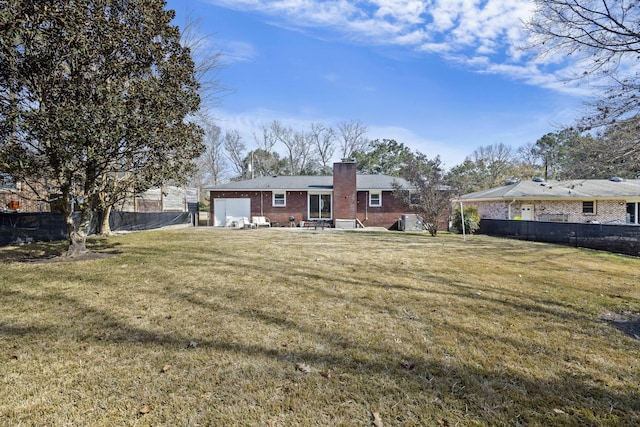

{"left": 205, "top": 161, "right": 412, "bottom": 228}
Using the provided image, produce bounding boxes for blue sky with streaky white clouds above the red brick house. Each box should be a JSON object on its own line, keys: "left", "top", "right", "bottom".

{"left": 168, "top": 0, "right": 587, "bottom": 168}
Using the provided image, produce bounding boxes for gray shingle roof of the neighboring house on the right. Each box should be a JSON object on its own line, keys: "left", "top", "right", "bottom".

{"left": 460, "top": 179, "right": 640, "bottom": 200}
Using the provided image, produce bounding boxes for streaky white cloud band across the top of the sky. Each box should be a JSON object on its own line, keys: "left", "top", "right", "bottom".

{"left": 202, "top": 0, "right": 582, "bottom": 97}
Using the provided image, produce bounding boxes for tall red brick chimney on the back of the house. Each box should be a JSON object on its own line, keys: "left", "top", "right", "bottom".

{"left": 333, "top": 159, "right": 358, "bottom": 219}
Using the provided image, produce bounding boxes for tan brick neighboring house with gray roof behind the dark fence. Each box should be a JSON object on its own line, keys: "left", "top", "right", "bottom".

{"left": 458, "top": 178, "right": 640, "bottom": 224}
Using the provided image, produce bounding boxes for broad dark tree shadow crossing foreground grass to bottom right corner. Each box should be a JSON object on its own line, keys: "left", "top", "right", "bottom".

{"left": 0, "top": 282, "right": 640, "bottom": 425}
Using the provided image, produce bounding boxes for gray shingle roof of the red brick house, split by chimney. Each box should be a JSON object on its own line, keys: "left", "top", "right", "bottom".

{"left": 204, "top": 175, "right": 413, "bottom": 191}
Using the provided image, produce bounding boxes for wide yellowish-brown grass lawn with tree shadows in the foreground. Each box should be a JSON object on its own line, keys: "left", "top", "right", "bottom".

{"left": 0, "top": 228, "right": 640, "bottom": 426}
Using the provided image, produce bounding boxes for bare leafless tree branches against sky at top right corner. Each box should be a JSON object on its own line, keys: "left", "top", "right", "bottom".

{"left": 527, "top": 0, "right": 640, "bottom": 127}
